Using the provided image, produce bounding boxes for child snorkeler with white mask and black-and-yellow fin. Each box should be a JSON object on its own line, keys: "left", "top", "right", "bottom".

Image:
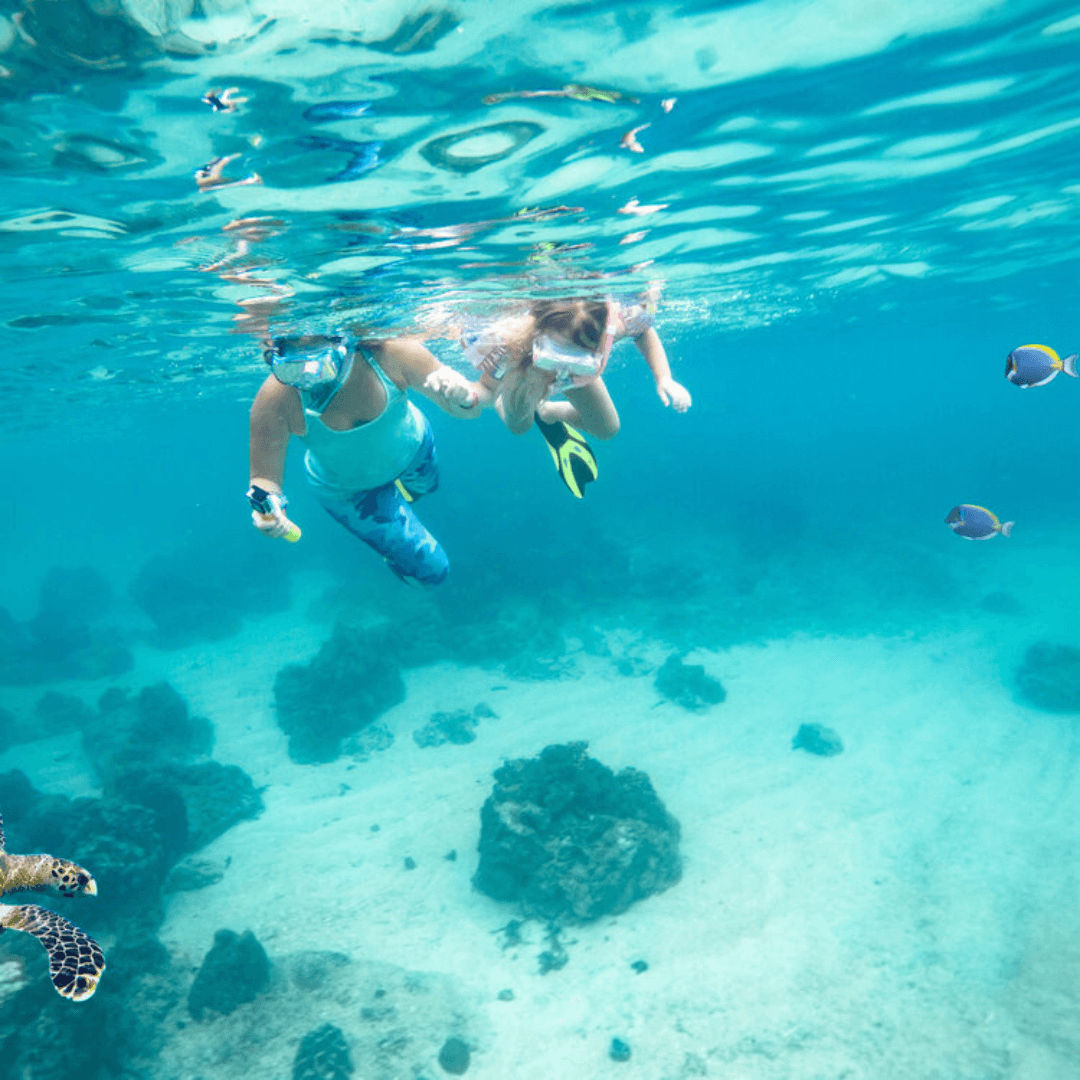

{"left": 461, "top": 297, "right": 691, "bottom": 499}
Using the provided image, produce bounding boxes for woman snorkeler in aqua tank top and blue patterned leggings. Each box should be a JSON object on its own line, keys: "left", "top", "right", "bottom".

{"left": 247, "top": 334, "right": 486, "bottom": 585}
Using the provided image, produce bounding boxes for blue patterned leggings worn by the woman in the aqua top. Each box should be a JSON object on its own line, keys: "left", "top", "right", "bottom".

{"left": 308, "top": 424, "right": 450, "bottom": 585}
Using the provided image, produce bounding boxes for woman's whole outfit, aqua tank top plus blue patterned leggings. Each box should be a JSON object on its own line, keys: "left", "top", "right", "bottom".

{"left": 300, "top": 349, "right": 449, "bottom": 585}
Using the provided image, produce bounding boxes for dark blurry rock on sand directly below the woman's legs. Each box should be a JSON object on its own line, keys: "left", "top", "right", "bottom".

{"left": 274, "top": 624, "right": 405, "bottom": 765}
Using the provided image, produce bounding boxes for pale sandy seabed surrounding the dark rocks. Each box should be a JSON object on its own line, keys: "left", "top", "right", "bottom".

{"left": 0, "top": 587, "right": 1080, "bottom": 1080}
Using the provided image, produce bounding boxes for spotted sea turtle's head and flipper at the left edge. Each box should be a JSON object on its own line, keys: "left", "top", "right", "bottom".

{"left": 0, "top": 818, "right": 105, "bottom": 1001}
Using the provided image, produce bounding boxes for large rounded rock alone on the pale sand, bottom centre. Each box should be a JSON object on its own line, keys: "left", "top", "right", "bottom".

{"left": 473, "top": 742, "right": 681, "bottom": 921}
